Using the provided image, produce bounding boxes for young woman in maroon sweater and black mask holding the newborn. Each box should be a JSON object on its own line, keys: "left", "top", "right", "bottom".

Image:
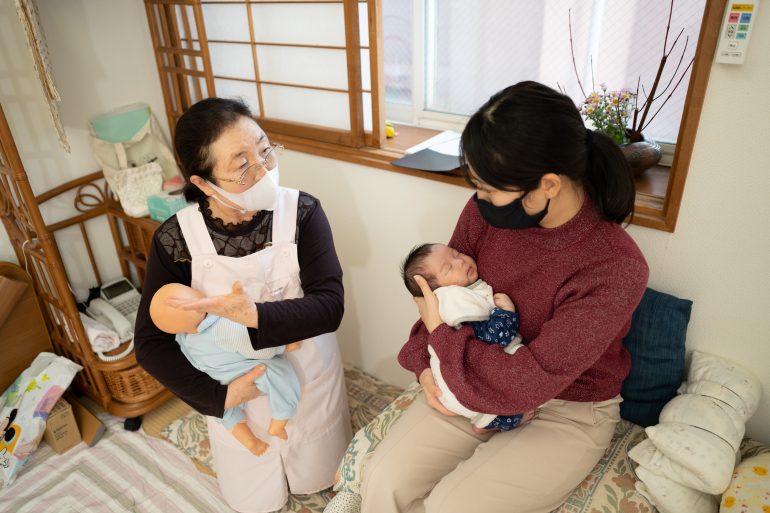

{"left": 362, "top": 82, "right": 648, "bottom": 513}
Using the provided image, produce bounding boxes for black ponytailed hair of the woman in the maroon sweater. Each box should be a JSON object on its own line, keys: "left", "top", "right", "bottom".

{"left": 460, "top": 82, "right": 636, "bottom": 223}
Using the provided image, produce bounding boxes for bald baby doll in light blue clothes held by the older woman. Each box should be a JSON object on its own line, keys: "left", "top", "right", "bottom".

{"left": 150, "top": 283, "right": 300, "bottom": 456}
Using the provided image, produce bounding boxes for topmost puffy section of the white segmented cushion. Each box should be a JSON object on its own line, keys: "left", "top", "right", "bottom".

{"left": 687, "top": 351, "right": 762, "bottom": 422}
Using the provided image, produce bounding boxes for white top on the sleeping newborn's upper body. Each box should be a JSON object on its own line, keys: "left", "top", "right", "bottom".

{"left": 433, "top": 280, "right": 495, "bottom": 328}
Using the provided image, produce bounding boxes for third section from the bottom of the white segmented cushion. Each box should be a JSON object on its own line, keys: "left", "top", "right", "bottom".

{"left": 660, "top": 394, "right": 746, "bottom": 451}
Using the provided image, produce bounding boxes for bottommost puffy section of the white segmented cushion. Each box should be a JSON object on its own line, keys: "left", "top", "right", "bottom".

{"left": 636, "top": 467, "right": 719, "bottom": 513}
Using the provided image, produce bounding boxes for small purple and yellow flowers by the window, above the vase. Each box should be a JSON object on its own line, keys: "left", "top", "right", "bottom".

{"left": 578, "top": 84, "right": 636, "bottom": 144}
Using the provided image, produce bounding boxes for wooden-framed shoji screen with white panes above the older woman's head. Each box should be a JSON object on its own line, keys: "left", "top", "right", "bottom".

{"left": 146, "top": 0, "right": 382, "bottom": 146}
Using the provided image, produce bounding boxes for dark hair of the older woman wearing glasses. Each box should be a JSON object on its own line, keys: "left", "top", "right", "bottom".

{"left": 174, "top": 98, "right": 253, "bottom": 201}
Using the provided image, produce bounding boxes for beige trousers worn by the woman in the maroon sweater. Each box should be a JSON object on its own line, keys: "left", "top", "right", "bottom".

{"left": 361, "top": 394, "right": 621, "bottom": 513}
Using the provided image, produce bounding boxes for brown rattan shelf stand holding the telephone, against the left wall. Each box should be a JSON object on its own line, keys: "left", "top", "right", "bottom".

{"left": 0, "top": 117, "right": 172, "bottom": 418}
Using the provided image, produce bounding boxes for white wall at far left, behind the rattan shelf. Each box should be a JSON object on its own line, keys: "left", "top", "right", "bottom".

{"left": 0, "top": 0, "right": 168, "bottom": 295}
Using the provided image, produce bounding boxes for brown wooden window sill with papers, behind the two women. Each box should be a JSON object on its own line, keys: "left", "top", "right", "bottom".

{"left": 271, "top": 125, "right": 673, "bottom": 232}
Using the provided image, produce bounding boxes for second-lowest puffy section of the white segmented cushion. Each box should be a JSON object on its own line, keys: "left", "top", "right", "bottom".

{"left": 645, "top": 422, "right": 735, "bottom": 494}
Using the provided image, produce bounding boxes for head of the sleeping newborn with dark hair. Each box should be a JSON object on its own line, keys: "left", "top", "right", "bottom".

{"left": 401, "top": 244, "right": 479, "bottom": 297}
